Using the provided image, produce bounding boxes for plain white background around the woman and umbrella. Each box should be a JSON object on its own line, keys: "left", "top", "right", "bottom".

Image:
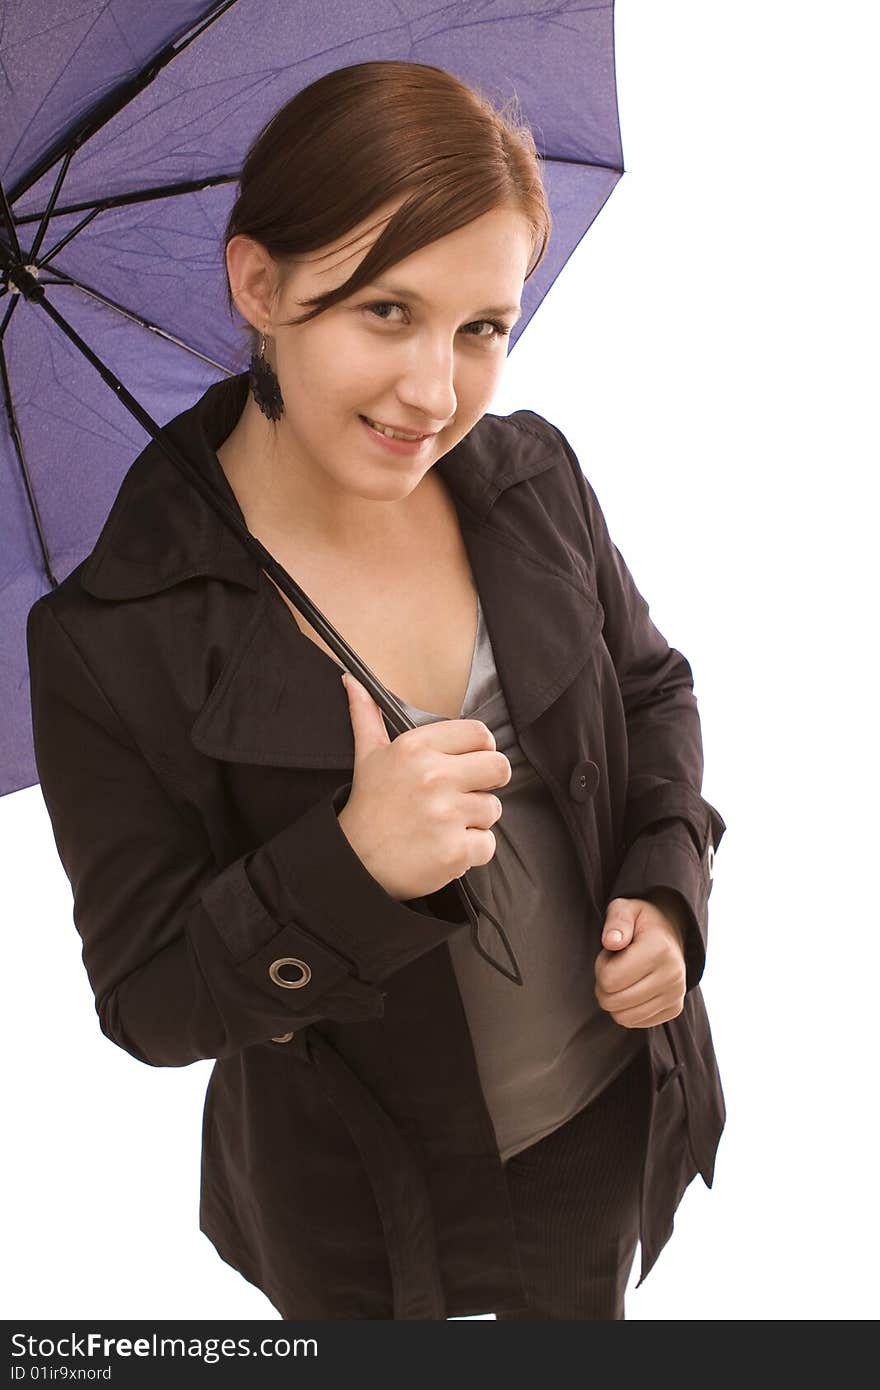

{"left": 0, "top": 0, "right": 880, "bottom": 1319}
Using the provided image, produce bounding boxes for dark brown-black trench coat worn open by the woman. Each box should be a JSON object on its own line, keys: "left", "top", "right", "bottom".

{"left": 28, "top": 374, "right": 726, "bottom": 1319}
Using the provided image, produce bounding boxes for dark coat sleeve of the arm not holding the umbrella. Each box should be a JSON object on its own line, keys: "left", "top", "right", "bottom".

{"left": 552, "top": 425, "right": 726, "bottom": 990}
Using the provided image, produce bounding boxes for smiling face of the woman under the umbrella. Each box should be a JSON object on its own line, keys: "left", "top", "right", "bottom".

{"left": 261, "top": 204, "right": 532, "bottom": 511}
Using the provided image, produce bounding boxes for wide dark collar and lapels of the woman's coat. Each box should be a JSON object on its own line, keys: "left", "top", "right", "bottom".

{"left": 79, "top": 373, "right": 603, "bottom": 770}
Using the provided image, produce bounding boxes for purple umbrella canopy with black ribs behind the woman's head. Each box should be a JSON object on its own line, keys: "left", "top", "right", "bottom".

{"left": 0, "top": 0, "right": 623, "bottom": 795}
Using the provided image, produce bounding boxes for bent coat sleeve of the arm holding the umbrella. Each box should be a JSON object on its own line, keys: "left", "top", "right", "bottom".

{"left": 26, "top": 599, "right": 467, "bottom": 1066}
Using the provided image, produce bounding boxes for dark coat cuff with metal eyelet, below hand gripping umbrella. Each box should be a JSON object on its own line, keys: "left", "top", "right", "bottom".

{"left": 202, "top": 781, "right": 470, "bottom": 1016}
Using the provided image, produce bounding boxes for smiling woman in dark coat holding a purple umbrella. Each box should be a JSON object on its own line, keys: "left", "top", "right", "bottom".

{"left": 28, "top": 63, "right": 724, "bottom": 1319}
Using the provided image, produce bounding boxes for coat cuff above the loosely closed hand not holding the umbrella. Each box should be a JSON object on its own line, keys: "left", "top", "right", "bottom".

{"left": 609, "top": 821, "right": 715, "bottom": 992}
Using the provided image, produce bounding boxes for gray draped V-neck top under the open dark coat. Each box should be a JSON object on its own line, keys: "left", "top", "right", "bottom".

{"left": 396, "top": 596, "right": 645, "bottom": 1161}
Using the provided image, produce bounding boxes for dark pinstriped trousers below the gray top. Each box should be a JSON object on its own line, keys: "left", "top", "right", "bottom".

{"left": 496, "top": 1047, "right": 651, "bottom": 1322}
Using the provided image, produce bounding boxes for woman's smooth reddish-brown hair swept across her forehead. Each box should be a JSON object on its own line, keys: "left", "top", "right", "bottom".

{"left": 224, "top": 60, "right": 552, "bottom": 346}
